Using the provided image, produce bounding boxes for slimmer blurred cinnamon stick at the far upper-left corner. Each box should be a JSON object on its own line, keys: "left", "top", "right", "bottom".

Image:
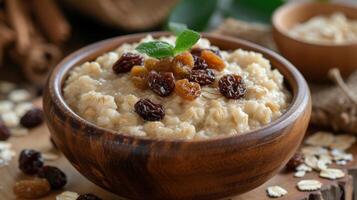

{"left": 5, "top": 0, "right": 31, "bottom": 55}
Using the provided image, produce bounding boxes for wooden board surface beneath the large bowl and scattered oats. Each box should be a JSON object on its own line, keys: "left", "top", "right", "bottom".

{"left": 0, "top": 99, "right": 357, "bottom": 200}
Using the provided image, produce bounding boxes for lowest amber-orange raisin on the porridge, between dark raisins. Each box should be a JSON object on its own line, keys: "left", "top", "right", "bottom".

{"left": 175, "top": 79, "right": 201, "bottom": 101}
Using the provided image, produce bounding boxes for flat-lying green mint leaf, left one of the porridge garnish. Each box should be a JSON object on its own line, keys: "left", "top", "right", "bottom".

{"left": 136, "top": 40, "right": 174, "bottom": 58}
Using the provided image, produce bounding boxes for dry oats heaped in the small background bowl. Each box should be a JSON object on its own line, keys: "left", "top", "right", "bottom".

{"left": 289, "top": 12, "right": 357, "bottom": 44}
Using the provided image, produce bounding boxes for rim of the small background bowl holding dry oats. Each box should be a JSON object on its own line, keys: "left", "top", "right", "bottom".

{"left": 272, "top": 2, "right": 357, "bottom": 48}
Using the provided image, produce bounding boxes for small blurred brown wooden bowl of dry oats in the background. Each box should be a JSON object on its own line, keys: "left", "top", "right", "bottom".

{"left": 273, "top": 2, "right": 357, "bottom": 82}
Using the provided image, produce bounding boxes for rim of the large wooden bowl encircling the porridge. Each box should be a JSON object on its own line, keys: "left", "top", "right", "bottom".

{"left": 44, "top": 32, "right": 310, "bottom": 146}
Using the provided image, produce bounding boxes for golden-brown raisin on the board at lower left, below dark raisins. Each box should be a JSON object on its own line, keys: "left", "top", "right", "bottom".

{"left": 13, "top": 178, "right": 51, "bottom": 199}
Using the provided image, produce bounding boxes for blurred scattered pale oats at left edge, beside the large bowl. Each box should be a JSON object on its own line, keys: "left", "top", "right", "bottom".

{"left": 0, "top": 81, "right": 34, "bottom": 136}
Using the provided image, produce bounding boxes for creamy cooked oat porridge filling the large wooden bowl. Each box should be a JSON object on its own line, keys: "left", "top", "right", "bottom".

{"left": 63, "top": 36, "right": 291, "bottom": 139}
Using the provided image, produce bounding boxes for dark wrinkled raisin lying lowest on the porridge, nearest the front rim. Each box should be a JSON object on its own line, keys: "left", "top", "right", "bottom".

{"left": 134, "top": 99, "right": 165, "bottom": 121}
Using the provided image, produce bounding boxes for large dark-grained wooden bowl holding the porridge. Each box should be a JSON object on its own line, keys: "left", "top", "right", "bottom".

{"left": 43, "top": 33, "right": 311, "bottom": 199}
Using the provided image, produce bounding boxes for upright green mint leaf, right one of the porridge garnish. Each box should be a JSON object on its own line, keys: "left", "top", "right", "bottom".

{"left": 174, "top": 29, "right": 200, "bottom": 54}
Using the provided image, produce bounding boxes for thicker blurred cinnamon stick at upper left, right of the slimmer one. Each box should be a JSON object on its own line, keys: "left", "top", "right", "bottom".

{"left": 31, "top": 0, "right": 70, "bottom": 44}
